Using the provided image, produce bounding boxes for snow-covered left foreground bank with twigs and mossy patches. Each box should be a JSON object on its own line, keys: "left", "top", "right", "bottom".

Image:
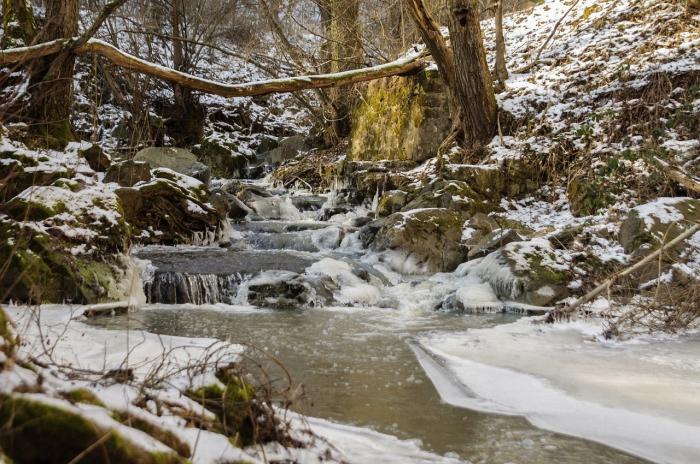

{"left": 0, "top": 305, "right": 470, "bottom": 464}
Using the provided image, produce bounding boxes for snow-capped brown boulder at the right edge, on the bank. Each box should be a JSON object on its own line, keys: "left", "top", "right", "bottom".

{"left": 618, "top": 197, "right": 700, "bottom": 253}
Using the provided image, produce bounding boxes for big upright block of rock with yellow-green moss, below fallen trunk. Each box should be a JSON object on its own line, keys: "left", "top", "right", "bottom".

{"left": 348, "top": 70, "right": 451, "bottom": 163}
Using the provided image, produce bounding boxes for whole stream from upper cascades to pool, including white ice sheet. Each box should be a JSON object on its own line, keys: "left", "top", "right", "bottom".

{"left": 87, "top": 186, "right": 700, "bottom": 464}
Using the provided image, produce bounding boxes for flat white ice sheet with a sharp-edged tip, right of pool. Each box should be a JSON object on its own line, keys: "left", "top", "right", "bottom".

{"left": 415, "top": 319, "right": 700, "bottom": 463}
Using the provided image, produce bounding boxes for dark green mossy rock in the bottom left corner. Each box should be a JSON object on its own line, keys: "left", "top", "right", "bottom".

{"left": 0, "top": 394, "right": 185, "bottom": 464}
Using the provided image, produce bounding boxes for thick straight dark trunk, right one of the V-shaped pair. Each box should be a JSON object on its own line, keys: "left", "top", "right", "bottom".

{"left": 449, "top": 0, "right": 498, "bottom": 148}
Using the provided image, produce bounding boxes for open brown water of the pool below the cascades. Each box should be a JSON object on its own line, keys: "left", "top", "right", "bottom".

{"left": 90, "top": 306, "right": 643, "bottom": 464}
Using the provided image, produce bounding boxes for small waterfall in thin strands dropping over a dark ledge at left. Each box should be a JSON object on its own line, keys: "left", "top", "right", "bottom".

{"left": 144, "top": 272, "right": 243, "bottom": 305}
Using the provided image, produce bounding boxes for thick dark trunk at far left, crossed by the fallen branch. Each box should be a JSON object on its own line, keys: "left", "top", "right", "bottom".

{"left": 29, "top": 0, "right": 80, "bottom": 148}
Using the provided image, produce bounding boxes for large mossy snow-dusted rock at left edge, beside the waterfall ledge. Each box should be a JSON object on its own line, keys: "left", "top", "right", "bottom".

{"left": 0, "top": 186, "right": 130, "bottom": 304}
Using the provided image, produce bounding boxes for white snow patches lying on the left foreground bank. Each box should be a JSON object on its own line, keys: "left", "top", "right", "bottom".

{"left": 5, "top": 305, "right": 468, "bottom": 464}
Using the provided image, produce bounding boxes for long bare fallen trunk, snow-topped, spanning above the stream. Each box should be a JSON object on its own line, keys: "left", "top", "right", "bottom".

{"left": 0, "top": 39, "right": 427, "bottom": 98}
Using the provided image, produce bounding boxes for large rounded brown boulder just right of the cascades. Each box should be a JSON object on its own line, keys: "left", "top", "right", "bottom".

{"left": 372, "top": 208, "right": 467, "bottom": 273}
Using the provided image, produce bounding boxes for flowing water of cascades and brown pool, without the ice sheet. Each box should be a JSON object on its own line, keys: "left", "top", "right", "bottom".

{"left": 95, "top": 187, "right": 642, "bottom": 464}
